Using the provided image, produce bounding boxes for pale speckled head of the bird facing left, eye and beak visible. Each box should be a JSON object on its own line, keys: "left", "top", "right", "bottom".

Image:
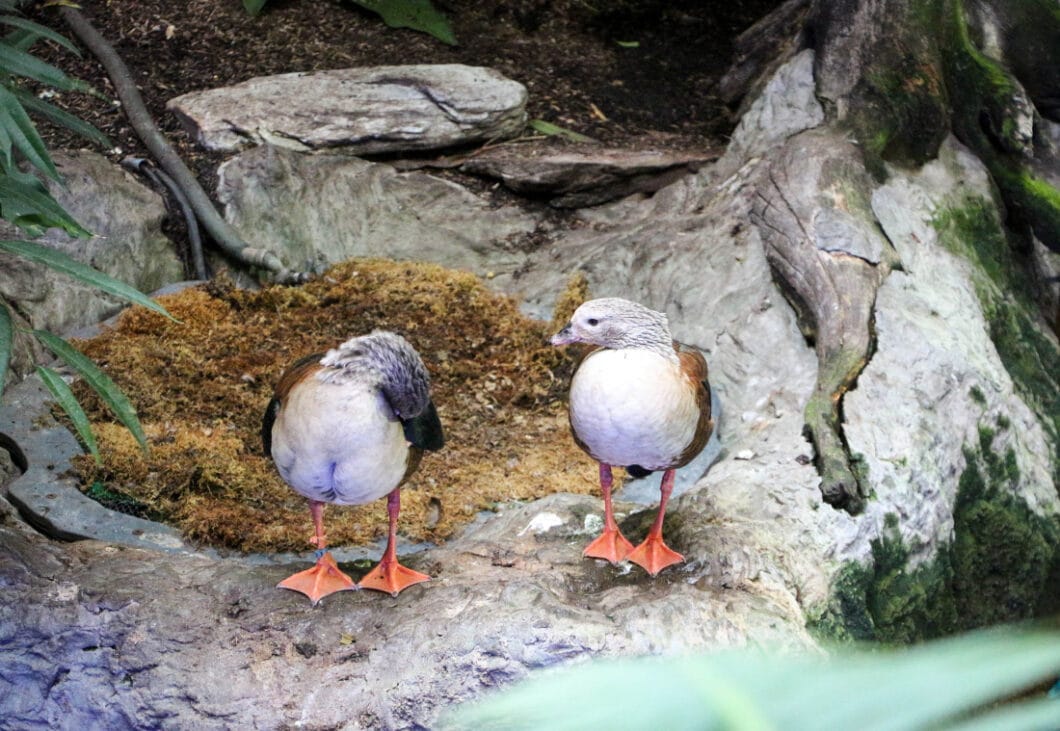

{"left": 551, "top": 297, "right": 673, "bottom": 354}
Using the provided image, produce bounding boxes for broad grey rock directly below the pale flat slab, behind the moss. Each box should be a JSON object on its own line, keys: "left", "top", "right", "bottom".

{"left": 217, "top": 145, "right": 538, "bottom": 275}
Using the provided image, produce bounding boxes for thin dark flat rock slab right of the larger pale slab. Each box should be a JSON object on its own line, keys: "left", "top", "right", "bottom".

{"left": 460, "top": 145, "right": 718, "bottom": 208}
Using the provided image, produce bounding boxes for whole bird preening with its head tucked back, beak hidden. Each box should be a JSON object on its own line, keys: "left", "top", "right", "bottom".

{"left": 262, "top": 331, "right": 444, "bottom": 604}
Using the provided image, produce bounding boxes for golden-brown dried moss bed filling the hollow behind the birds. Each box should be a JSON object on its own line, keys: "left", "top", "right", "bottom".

{"left": 77, "top": 260, "right": 596, "bottom": 552}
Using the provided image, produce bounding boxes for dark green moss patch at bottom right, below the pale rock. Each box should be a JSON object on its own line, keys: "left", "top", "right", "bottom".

{"left": 809, "top": 427, "right": 1060, "bottom": 643}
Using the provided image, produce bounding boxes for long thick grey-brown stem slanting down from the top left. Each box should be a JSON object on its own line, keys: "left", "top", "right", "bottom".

{"left": 59, "top": 7, "right": 308, "bottom": 283}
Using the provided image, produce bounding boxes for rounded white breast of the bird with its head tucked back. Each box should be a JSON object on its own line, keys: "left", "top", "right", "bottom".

{"left": 272, "top": 377, "right": 408, "bottom": 505}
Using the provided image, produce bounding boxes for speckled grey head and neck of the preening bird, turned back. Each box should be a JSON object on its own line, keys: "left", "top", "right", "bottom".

{"left": 317, "top": 329, "right": 430, "bottom": 420}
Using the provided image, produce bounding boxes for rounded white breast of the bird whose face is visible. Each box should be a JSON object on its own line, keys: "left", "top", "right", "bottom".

{"left": 570, "top": 350, "right": 700, "bottom": 469}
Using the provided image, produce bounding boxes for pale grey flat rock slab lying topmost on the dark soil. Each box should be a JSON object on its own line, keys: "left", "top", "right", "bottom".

{"left": 166, "top": 64, "right": 527, "bottom": 155}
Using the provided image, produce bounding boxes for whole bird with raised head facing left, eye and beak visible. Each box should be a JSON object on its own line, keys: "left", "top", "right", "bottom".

{"left": 551, "top": 297, "right": 714, "bottom": 576}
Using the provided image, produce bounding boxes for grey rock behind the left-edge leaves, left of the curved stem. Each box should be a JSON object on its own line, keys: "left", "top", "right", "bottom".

{"left": 0, "top": 151, "right": 183, "bottom": 379}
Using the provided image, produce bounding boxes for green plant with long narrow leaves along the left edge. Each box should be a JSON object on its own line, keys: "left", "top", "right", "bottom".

{"left": 0, "top": 0, "right": 169, "bottom": 462}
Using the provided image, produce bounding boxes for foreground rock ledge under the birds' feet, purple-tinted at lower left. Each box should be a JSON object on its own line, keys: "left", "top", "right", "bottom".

{"left": 0, "top": 421, "right": 813, "bottom": 729}
